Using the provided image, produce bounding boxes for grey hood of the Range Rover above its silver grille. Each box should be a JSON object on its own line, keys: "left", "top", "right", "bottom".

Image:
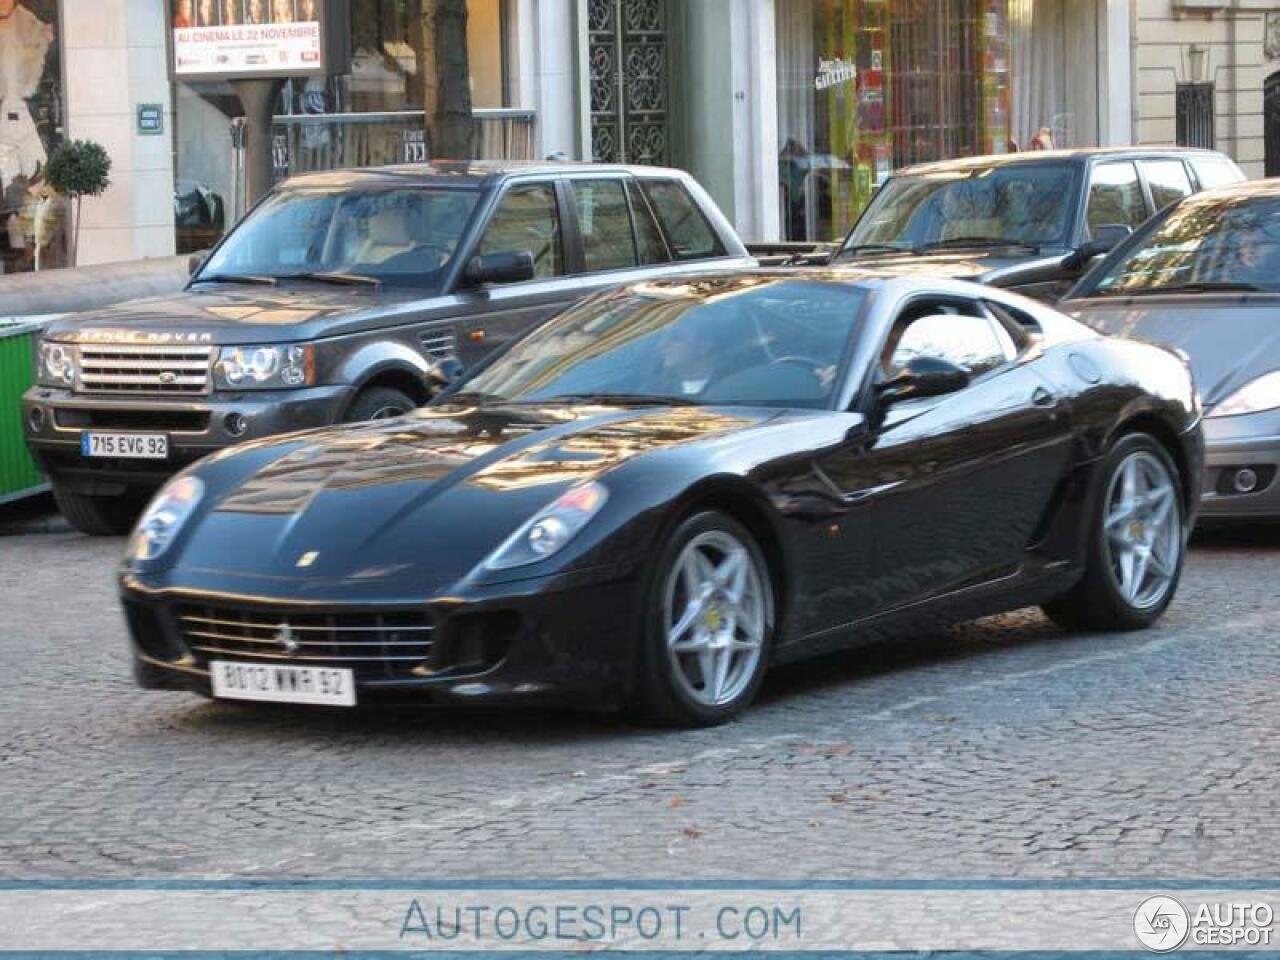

{"left": 45, "top": 284, "right": 419, "bottom": 344}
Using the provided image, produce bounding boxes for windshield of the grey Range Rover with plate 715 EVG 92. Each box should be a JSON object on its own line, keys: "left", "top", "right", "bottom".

{"left": 193, "top": 187, "right": 477, "bottom": 292}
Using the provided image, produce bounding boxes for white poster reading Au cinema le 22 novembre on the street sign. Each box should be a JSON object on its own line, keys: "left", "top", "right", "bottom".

{"left": 172, "top": 0, "right": 324, "bottom": 79}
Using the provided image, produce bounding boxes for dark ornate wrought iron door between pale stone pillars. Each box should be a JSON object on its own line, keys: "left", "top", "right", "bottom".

{"left": 586, "top": 0, "right": 667, "bottom": 164}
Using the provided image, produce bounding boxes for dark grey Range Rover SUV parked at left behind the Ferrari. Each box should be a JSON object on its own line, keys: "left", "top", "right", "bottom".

{"left": 23, "top": 164, "right": 753, "bottom": 534}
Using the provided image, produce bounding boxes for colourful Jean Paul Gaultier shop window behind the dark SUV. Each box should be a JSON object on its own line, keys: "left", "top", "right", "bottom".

{"left": 776, "top": 0, "right": 1097, "bottom": 241}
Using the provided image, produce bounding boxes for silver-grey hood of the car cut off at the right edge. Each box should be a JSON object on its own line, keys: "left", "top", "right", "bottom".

{"left": 1060, "top": 293, "right": 1280, "bottom": 407}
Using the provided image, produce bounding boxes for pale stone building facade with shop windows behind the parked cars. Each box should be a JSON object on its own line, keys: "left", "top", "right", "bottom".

{"left": 0, "top": 0, "right": 1280, "bottom": 271}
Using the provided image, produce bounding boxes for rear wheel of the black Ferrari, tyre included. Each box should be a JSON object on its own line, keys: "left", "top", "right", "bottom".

{"left": 1044, "top": 434, "right": 1187, "bottom": 630}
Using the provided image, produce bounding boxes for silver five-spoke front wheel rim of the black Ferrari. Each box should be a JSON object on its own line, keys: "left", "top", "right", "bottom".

{"left": 663, "top": 530, "right": 773, "bottom": 707}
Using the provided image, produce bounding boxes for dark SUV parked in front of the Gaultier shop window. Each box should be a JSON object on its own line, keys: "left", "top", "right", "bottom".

{"left": 831, "top": 147, "right": 1244, "bottom": 302}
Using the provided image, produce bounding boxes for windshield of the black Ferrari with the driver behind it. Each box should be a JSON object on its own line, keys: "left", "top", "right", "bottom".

{"left": 457, "top": 276, "right": 865, "bottom": 408}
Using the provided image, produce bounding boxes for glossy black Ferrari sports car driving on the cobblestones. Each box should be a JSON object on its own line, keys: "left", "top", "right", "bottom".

{"left": 120, "top": 270, "right": 1203, "bottom": 724}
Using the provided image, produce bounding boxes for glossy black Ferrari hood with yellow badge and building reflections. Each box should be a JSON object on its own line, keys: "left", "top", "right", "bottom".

{"left": 170, "top": 404, "right": 771, "bottom": 593}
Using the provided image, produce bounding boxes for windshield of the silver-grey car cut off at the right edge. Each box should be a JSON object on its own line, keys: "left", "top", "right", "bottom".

{"left": 1076, "top": 195, "right": 1280, "bottom": 297}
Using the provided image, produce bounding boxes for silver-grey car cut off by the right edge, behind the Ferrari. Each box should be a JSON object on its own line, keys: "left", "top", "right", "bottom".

{"left": 1059, "top": 179, "right": 1280, "bottom": 520}
